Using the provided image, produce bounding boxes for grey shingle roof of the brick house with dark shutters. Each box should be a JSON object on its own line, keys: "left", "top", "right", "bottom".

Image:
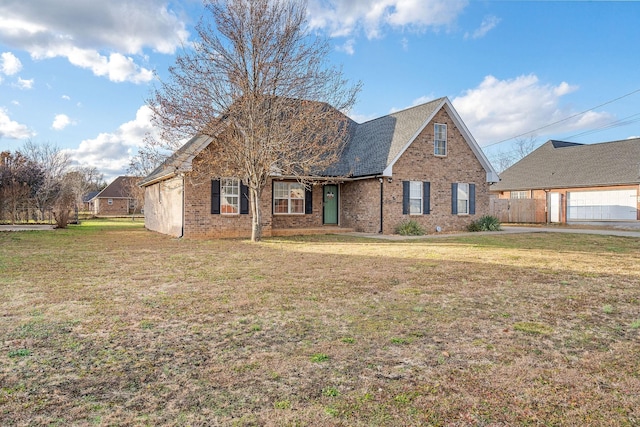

{"left": 140, "top": 97, "right": 499, "bottom": 186}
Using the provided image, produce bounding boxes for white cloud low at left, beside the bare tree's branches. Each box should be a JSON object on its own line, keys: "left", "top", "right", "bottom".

{"left": 67, "top": 105, "right": 154, "bottom": 177}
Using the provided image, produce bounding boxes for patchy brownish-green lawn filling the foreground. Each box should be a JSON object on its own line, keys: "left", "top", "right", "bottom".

{"left": 0, "top": 219, "right": 640, "bottom": 426}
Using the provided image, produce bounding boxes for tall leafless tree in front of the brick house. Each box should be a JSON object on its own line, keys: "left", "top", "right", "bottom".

{"left": 148, "top": 0, "right": 360, "bottom": 241}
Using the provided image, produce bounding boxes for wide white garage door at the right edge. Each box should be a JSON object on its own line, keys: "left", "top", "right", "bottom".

{"left": 567, "top": 190, "right": 638, "bottom": 221}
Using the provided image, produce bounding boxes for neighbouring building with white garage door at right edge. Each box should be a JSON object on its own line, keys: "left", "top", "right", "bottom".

{"left": 491, "top": 138, "right": 640, "bottom": 222}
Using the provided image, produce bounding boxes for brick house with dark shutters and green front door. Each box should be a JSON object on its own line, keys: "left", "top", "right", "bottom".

{"left": 140, "top": 98, "right": 499, "bottom": 237}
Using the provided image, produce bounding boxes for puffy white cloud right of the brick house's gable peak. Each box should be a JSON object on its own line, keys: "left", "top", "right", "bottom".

{"left": 452, "top": 74, "right": 612, "bottom": 145}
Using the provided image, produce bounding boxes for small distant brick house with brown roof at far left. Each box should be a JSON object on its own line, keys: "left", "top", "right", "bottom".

{"left": 89, "top": 176, "right": 144, "bottom": 215}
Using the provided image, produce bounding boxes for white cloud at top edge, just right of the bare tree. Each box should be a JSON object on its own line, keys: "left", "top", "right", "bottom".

{"left": 308, "top": 0, "right": 468, "bottom": 38}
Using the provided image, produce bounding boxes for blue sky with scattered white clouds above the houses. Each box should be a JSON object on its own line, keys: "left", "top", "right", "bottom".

{"left": 0, "top": 0, "right": 640, "bottom": 182}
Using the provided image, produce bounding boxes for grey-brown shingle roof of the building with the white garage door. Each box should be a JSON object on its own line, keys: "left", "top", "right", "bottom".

{"left": 491, "top": 138, "right": 640, "bottom": 191}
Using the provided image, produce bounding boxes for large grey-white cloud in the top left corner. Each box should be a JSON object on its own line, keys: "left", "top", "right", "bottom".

{"left": 0, "top": 0, "right": 189, "bottom": 83}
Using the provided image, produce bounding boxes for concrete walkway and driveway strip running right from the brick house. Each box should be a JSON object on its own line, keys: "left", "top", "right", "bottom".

{"left": 344, "top": 225, "right": 640, "bottom": 241}
